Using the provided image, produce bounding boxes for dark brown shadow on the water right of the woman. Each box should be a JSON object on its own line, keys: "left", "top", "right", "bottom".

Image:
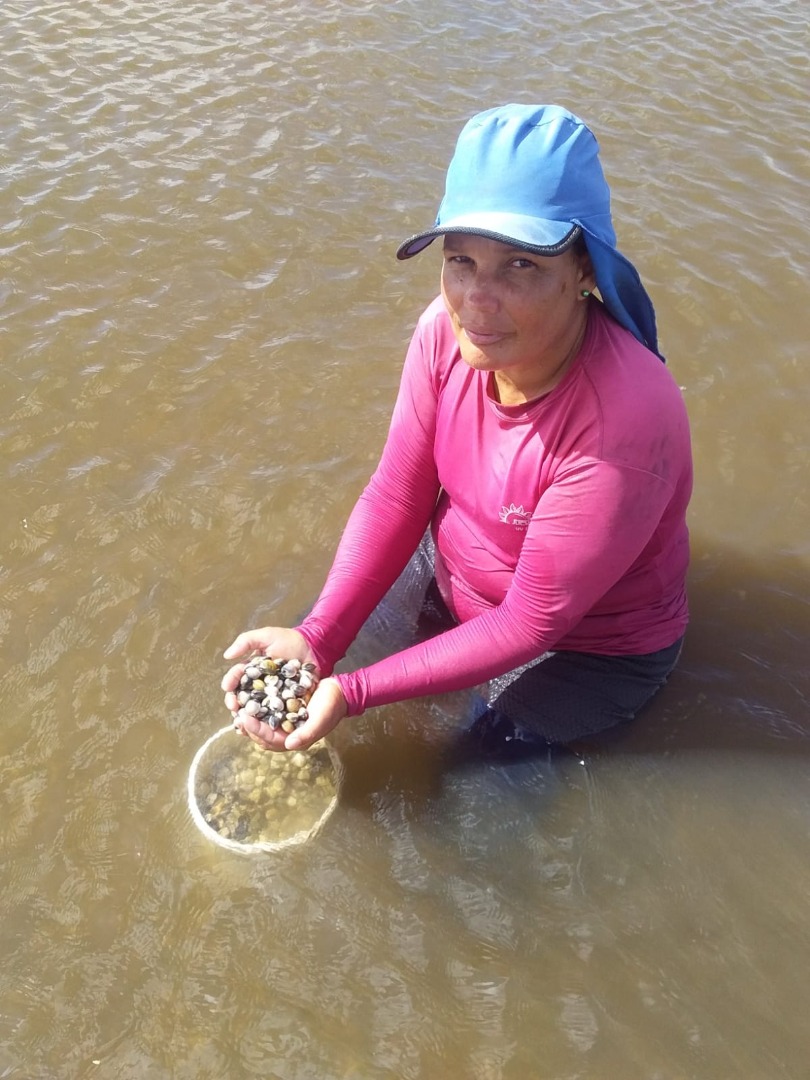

{"left": 583, "top": 543, "right": 810, "bottom": 756}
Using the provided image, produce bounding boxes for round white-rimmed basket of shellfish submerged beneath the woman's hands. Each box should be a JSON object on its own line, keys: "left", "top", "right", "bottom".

{"left": 188, "top": 725, "right": 339, "bottom": 852}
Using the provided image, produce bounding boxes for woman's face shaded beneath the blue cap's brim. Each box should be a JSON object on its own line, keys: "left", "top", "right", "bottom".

{"left": 442, "top": 233, "right": 594, "bottom": 384}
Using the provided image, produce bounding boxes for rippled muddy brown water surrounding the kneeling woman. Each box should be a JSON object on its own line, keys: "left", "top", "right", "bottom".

{"left": 0, "top": 0, "right": 810, "bottom": 1080}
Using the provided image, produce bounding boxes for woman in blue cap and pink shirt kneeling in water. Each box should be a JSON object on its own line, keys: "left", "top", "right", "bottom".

{"left": 222, "top": 105, "right": 691, "bottom": 750}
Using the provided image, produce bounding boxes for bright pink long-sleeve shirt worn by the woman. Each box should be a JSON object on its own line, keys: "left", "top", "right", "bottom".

{"left": 298, "top": 298, "right": 692, "bottom": 716}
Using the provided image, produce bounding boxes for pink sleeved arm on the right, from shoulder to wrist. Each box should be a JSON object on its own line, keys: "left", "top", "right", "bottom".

{"left": 337, "top": 461, "right": 672, "bottom": 716}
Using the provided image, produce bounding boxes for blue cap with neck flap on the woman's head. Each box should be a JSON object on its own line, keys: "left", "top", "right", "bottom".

{"left": 396, "top": 105, "right": 663, "bottom": 360}
